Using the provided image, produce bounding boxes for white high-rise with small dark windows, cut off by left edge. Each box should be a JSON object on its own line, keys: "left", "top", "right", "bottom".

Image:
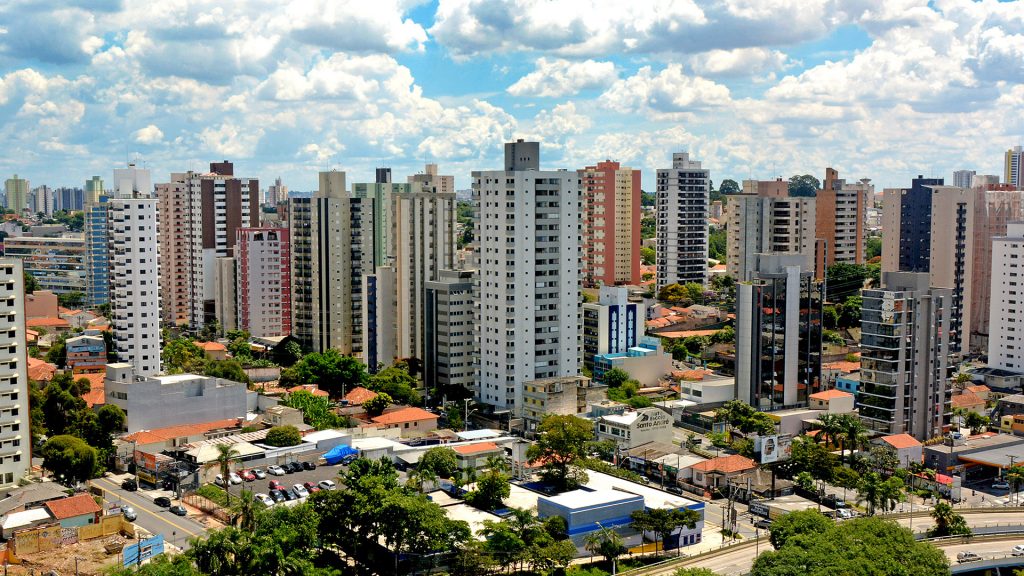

{"left": 0, "top": 258, "right": 32, "bottom": 488}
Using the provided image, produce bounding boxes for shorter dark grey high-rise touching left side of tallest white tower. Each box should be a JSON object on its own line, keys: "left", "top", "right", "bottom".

{"left": 423, "top": 270, "right": 478, "bottom": 397}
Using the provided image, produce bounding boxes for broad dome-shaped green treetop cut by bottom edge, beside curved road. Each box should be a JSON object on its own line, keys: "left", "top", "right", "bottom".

{"left": 751, "top": 518, "right": 949, "bottom": 576}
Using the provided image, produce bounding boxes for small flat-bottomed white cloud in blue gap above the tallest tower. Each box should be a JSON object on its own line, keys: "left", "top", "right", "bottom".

{"left": 508, "top": 56, "right": 618, "bottom": 97}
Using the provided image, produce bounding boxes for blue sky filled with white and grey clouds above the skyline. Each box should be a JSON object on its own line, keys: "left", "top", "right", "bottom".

{"left": 0, "top": 0, "right": 1024, "bottom": 191}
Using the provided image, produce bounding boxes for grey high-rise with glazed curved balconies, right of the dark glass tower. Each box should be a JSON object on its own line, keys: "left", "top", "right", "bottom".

{"left": 857, "top": 272, "right": 952, "bottom": 440}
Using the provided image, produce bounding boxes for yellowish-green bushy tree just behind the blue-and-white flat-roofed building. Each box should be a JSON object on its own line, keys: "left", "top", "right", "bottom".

{"left": 526, "top": 414, "right": 594, "bottom": 491}
